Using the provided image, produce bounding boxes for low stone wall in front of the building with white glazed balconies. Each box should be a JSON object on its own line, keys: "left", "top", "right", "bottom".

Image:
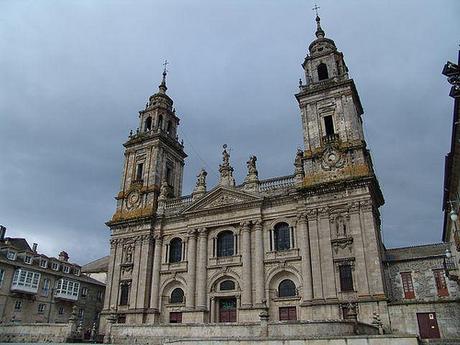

{"left": 0, "top": 323, "right": 72, "bottom": 343}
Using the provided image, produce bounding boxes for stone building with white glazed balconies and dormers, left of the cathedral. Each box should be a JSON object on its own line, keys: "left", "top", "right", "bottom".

{"left": 0, "top": 226, "right": 105, "bottom": 331}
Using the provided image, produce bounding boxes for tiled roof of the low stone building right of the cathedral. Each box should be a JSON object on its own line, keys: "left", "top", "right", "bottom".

{"left": 385, "top": 243, "right": 449, "bottom": 261}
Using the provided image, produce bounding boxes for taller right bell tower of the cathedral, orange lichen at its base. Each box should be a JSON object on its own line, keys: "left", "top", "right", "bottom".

{"left": 295, "top": 15, "right": 383, "bottom": 191}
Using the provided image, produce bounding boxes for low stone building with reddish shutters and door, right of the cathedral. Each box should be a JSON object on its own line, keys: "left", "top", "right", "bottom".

{"left": 384, "top": 243, "right": 460, "bottom": 338}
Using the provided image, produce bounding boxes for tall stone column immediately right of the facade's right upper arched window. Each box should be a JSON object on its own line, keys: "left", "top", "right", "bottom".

{"left": 297, "top": 213, "right": 313, "bottom": 301}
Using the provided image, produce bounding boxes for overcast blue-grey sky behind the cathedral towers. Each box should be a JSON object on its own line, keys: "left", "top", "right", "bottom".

{"left": 0, "top": 0, "right": 460, "bottom": 264}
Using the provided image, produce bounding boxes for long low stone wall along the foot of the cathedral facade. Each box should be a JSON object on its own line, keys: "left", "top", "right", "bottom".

{"left": 106, "top": 321, "right": 378, "bottom": 344}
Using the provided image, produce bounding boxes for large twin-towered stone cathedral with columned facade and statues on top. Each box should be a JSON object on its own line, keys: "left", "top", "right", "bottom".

{"left": 101, "top": 16, "right": 459, "bottom": 344}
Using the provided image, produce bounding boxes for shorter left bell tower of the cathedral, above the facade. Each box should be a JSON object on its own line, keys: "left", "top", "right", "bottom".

{"left": 112, "top": 66, "right": 187, "bottom": 221}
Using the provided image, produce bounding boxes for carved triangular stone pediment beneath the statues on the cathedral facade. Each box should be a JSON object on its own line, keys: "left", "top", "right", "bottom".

{"left": 183, "top": 187, "right": 262, "bottom": 213}
